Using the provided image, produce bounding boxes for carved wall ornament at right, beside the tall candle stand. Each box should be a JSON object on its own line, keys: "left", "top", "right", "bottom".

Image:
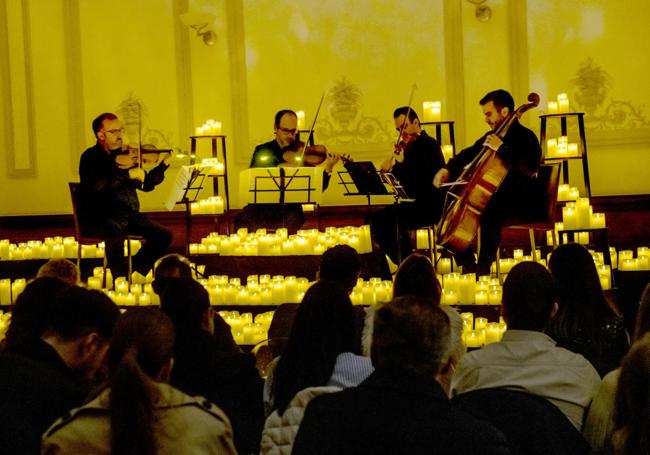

{"left": 569, "top": 57, "right": 650, "bottom": 130}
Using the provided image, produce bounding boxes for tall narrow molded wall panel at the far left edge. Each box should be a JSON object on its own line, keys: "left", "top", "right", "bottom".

{"left": 0, "top": 0, "right": 36, "bottom": 177}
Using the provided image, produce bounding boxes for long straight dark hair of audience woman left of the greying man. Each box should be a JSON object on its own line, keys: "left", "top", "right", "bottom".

{"left": 271, "top": 280, "right": 359, "bottom": 414}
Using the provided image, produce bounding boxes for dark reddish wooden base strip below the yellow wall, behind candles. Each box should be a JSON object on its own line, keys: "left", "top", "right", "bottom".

{"left": 0, "top": 195, "right": 650, "bottom": 252}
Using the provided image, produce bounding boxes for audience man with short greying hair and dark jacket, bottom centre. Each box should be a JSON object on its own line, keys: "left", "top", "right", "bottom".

{"left": 292, "top": 295, "right": 509, "bottom": 455}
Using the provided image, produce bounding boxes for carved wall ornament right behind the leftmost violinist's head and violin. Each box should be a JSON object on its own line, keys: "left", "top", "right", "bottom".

{"left": 116, "top": 94, "right": 173, "bottom": 149}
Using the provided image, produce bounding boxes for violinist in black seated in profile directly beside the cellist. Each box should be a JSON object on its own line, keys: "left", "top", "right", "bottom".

{"left": 370, "top": 106, "right": 445, "bottom": 264}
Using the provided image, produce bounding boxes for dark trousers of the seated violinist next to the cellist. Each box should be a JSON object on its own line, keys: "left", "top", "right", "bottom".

{"left": 369, "top": 202, "right": 436, "bottom": 265}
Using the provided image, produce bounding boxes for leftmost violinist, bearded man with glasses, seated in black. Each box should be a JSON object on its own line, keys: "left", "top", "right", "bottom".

{"left": 79, "top": 113, "right": 172, "bottom": 277}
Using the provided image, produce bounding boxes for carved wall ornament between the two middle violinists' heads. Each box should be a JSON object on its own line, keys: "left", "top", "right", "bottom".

{"left": 305, "top": 76, "right": 393, "bottom": 146}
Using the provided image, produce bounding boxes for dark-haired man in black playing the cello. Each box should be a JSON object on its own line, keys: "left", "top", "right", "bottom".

{"left": 433, "top": 89, "right": 542, "bottom": 276}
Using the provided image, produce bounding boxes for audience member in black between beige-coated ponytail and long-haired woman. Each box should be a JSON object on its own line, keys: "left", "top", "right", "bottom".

{"left": 161, "top": 278, "right": 264, "bottom": 455}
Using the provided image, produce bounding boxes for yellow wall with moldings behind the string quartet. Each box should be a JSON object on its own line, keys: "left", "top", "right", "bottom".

{"left": 0, "top": 0, "right": 650, "bottom": 216}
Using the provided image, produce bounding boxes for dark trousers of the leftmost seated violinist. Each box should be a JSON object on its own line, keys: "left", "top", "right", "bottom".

{"left": 100, "top": 213, "right": 172, "bottom": 277}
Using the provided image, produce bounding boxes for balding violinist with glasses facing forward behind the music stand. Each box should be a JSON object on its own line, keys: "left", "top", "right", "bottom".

{"left": 235, "top": 109, "right": 340, "bottom": 233}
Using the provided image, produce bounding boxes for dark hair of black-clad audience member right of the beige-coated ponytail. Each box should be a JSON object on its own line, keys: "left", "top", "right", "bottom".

{"left": 160, "top": 278, "right": 210, "bottom": 333}
